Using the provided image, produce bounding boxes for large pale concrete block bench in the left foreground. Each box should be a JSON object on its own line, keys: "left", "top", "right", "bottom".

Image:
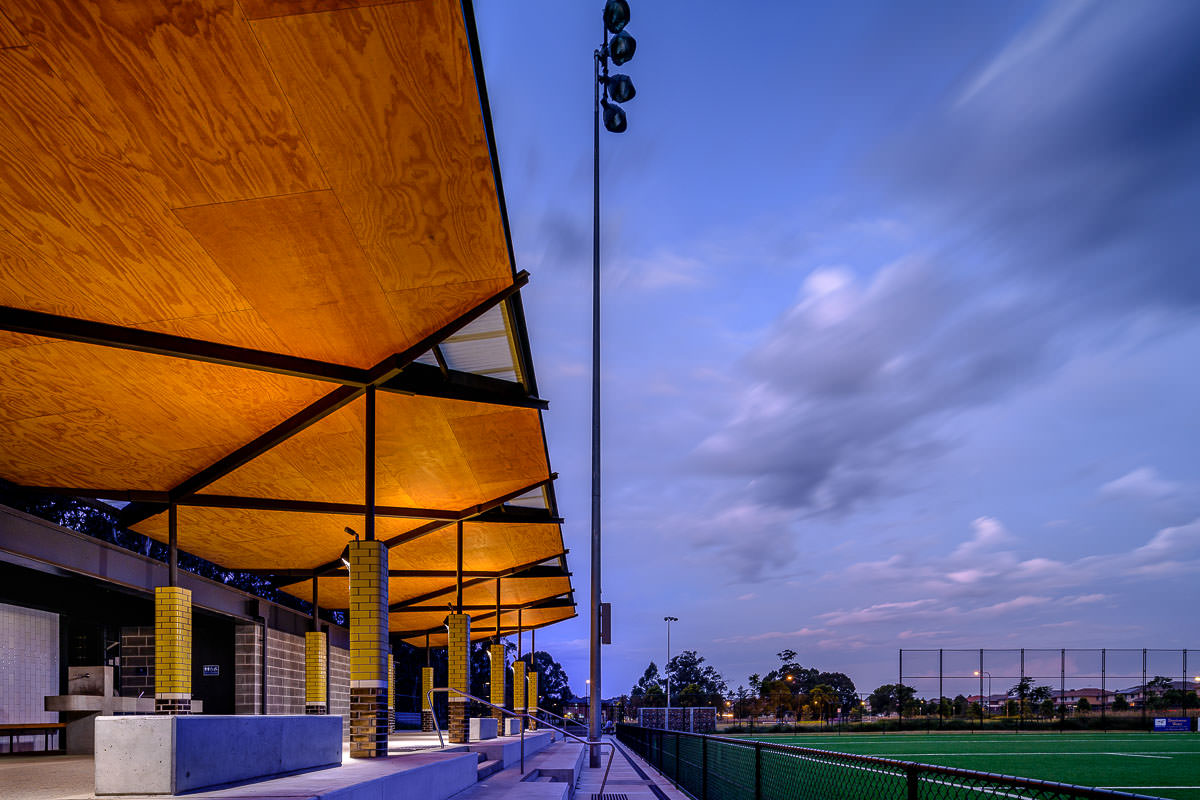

{"left": 96, "top": 715, "right": 342, "bottom": 795}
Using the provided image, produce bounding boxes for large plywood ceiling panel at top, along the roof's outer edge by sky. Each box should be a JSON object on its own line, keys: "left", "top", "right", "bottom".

{"left": 251, "top": 0, "right": 512, "bottom": 293}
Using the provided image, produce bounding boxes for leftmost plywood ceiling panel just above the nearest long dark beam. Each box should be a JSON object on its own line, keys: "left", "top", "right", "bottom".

{"left": 0, "top": 47, "right": 247, "bottom": 324}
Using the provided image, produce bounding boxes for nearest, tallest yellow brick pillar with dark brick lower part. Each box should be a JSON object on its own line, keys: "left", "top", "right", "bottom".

{"left": 350, "top": 540, "right": 388, "bottom": 758}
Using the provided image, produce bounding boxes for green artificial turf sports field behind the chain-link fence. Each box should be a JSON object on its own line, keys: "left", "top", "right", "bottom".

{"left": 738, "top": 732, "right": 1200, "bottom": 800}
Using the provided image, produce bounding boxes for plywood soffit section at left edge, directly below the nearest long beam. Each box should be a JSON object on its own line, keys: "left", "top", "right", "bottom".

{"left": 0, "top": 335, "right": 328, "bottom": 491}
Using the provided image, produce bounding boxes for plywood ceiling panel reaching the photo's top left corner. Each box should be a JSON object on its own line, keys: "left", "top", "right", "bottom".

{"left": 5, "top": 0, "right": 326, "bottom": 207}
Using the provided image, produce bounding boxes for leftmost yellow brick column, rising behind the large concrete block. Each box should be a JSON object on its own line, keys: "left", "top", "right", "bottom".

{"left": 154, "top": 587, "right": 192, "bottom": 714}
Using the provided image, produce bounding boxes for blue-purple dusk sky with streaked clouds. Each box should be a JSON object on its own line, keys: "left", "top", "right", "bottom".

{"left": 475, "top": 0, "right": 1200, "bottom": 696}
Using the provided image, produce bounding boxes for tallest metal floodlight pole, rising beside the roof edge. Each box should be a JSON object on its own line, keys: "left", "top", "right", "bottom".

{"left": 588, "top": 14, "right": 608, "bottom": 769}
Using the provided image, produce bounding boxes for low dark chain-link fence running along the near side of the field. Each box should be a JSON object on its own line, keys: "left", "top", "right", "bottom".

{"left": 617, "top": 724, "right": 1166, "bottom": 800}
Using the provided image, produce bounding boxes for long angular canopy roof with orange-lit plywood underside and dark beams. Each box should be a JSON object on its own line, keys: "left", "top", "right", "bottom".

{"left": 0, "top": 0, "right": 574, "bottom": 642}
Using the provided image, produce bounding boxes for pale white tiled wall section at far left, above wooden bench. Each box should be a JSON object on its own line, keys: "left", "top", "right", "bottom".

{"left": 0, "top": 603, "right": 59, "bottom": 752}
